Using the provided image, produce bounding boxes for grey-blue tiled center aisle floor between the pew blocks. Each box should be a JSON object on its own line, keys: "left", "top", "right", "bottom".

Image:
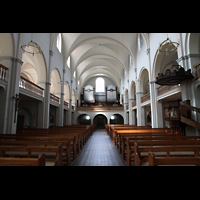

{"left": 73, "top": 129, "right": 125, "bottom": 166}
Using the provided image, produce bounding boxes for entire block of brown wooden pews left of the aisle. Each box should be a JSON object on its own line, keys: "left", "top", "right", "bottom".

{"left": 0, "top": 125, "right": 95, "bottom": 166}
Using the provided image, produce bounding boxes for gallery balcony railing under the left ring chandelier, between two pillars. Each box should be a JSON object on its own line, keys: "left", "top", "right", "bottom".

{"left": 19, "top": 76, "right": 44, "bottom": 97}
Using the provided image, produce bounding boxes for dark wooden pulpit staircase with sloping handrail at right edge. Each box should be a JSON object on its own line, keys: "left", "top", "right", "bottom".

{"left": 180, "top": 101, "right": 200, "bottom": 129}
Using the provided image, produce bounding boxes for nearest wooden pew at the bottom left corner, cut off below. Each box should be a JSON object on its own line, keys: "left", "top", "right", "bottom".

{"left": 0, "top": 154, "right": 46, "bottom": 166}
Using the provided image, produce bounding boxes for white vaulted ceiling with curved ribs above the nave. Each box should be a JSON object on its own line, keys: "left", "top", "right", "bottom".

{"left": 62, "top": 33, "right": 142, "bottom": 86}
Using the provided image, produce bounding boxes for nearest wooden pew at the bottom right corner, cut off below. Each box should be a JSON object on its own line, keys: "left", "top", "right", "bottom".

{"left": 148, "top": 152, "right": 200, "bottom": 166}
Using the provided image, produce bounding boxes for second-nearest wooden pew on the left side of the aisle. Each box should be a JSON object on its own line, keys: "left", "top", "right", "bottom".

{"left": 0, "top": 143, "right": 62, "bottom": 165}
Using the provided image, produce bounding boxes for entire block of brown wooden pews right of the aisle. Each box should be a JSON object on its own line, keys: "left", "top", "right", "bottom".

{"left": 105, "top": 124, "right": 200, "bottom": 166}
